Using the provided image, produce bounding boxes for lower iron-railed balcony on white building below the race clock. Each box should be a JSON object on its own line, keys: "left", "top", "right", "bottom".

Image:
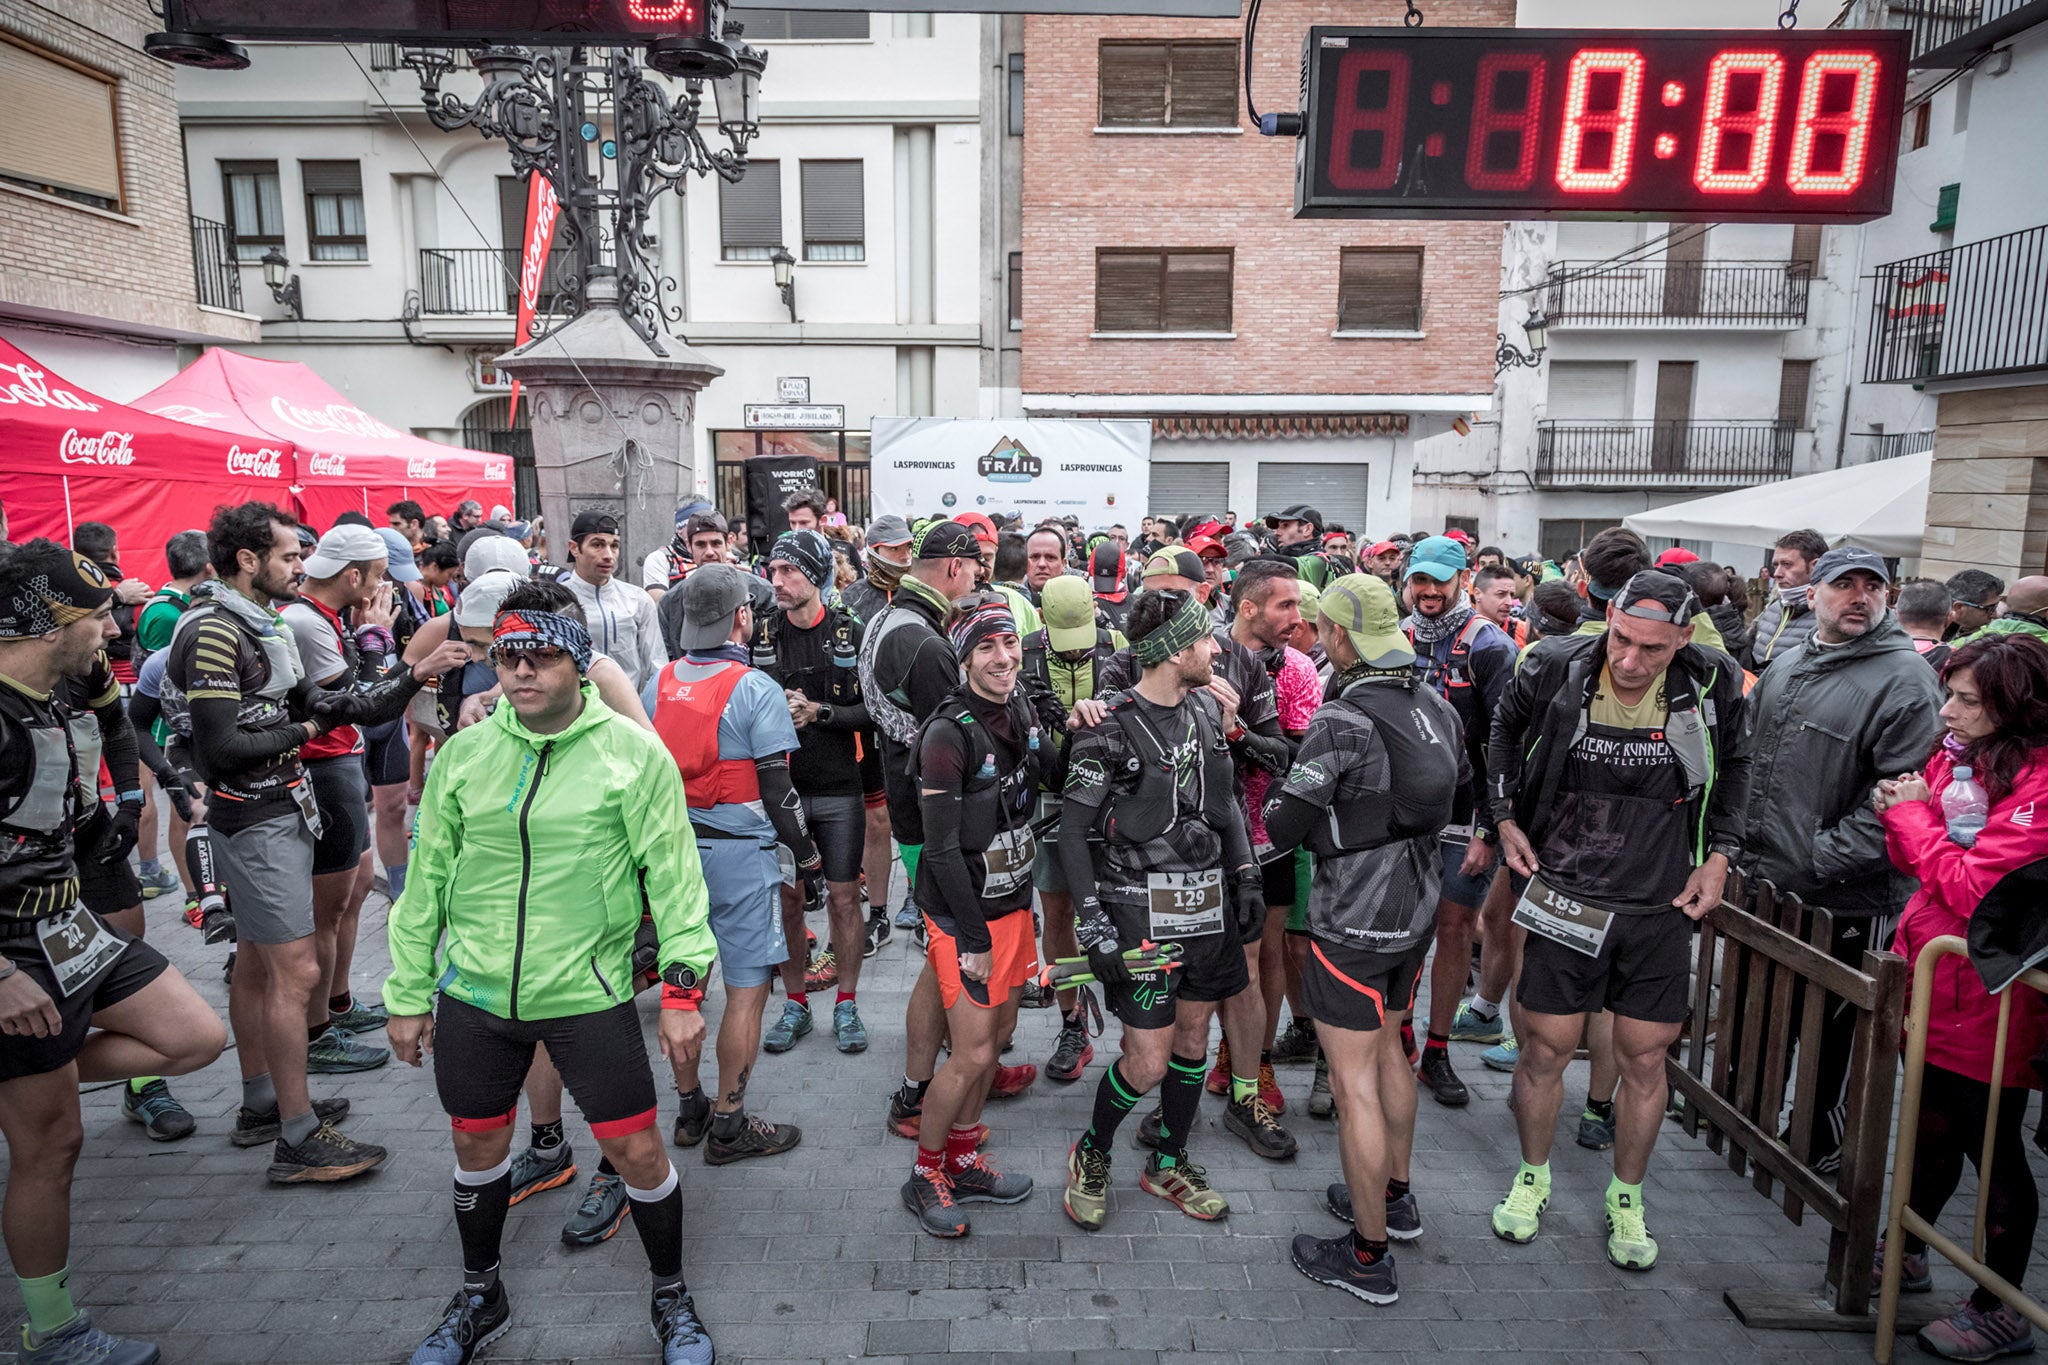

{"left": 1536, "top": 417, "right": 1798, "bottom": 489}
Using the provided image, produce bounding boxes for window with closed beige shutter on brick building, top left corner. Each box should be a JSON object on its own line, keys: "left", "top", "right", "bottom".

{"left": 0, "top": 38, "right": 121, "bottom": 213}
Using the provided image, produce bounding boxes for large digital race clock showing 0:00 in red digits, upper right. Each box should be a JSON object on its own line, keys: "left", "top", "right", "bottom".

{"left": 1294, "top": 27, "right": 1907, "bottom": 223}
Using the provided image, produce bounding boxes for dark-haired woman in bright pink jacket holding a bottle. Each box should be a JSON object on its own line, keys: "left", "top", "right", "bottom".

{"left": 1876, "top": 634, "right": 2048, "bottom": 1361}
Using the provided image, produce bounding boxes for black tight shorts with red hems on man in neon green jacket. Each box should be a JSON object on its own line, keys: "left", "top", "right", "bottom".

{"left": 434, "top": 995, "right": 655, "bottom": 1138}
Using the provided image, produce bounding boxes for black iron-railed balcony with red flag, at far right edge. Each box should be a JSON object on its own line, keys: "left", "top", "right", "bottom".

{"left": 1864, "top": 225, "right": 2048, "bottom": 385}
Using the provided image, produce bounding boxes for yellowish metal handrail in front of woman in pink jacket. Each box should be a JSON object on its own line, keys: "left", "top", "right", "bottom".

{"left": 1875, "top": 933, "right": 2048, "bottom": 1365}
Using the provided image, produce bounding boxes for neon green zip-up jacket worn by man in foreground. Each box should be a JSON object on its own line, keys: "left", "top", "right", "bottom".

{"left": 383, "top": 681, "right": 717, "bottom": 1019}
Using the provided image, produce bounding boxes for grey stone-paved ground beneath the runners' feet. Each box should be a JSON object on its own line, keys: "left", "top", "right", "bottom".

{"left": 0, "top": 878, "right": 2048, "bottom": 1365}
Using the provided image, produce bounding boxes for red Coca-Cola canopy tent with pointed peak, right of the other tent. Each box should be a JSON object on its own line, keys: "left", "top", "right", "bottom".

{"left": 135, "top": 348, "right": 512, "bottom": 528}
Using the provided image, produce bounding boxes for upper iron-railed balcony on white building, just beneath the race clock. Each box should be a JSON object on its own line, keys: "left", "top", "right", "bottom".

{"left": 1544, "top": 260, "right": 1812, "bottom": 327}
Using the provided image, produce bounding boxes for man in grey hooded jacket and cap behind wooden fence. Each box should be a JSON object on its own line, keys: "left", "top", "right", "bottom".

{"left": 1739, "top": 548, "right": 1942, "bottom": 1171}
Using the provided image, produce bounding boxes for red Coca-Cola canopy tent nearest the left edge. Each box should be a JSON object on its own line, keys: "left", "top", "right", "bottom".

{"left": 0, "top": 338, "right": 293, "bottom": 585}
